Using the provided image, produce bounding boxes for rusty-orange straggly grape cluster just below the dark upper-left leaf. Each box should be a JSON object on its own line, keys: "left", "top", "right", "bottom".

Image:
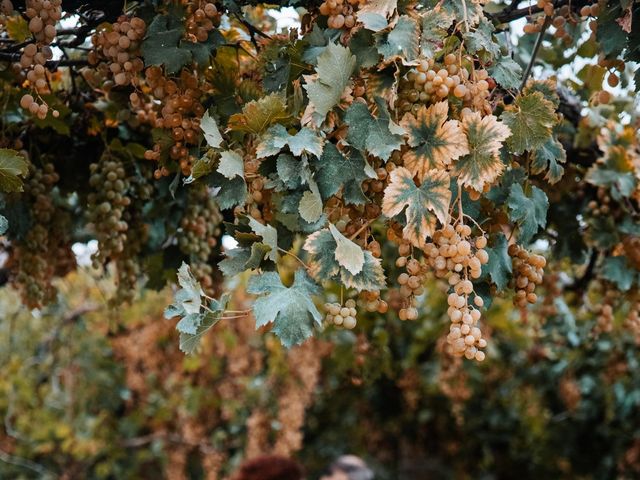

{"left": 141, "top": 67, "right": 205, "bottom": 178}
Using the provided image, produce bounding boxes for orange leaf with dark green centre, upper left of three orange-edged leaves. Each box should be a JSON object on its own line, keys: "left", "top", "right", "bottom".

{"left": 400, "top": 101, "right": 469, "bottom": 179}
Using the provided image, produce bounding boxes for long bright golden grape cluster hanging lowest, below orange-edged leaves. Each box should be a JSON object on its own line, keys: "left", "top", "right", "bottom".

{"left": 424, "top": 222, "right": 489, "bottom": 361}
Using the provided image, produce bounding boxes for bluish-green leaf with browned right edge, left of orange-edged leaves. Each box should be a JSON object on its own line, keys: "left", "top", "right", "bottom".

{"left": 345, "top": 98, "right": 404, "bottom": 161}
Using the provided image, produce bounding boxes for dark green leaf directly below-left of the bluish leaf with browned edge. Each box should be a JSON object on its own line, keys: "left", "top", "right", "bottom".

{"left": 311, "top": 143, "right": 368, "bottom": 205}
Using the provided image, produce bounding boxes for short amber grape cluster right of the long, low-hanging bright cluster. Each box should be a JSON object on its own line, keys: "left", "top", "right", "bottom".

{"left": 508, "top": 243, "right": 547, "bottom": 307}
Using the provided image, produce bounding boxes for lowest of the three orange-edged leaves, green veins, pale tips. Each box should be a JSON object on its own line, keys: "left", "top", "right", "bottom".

{"left": 382, "top": 167, "right": 451, "bottom": 248}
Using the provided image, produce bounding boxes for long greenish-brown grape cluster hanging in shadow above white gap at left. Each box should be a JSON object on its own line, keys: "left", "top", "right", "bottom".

{"left": 87, "top": 152, "right": 131, "bottom": 268}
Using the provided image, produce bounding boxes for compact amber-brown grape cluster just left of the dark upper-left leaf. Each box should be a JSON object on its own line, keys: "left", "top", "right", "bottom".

{"left": 87, "top": 15, "right": 146, "bottom": 89}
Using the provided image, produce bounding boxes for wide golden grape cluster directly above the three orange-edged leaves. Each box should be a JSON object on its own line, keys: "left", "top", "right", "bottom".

{"left": 399, "top": 53, "right": 495, "bottom": 117}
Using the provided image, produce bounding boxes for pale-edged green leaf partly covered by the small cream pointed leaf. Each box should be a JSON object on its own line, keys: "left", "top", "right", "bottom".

{"left": 303, "top": 228, "right": 385, "bottom": 292}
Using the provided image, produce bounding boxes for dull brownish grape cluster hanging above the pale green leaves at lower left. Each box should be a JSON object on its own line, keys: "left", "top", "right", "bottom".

{"left": 178, "top": 186, "right": 222, "bottom": 292}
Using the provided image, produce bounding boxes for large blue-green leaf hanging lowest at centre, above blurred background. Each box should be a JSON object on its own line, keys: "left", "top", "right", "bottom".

{"left": 247, "top": 269, "right": 322, "bottom": 348}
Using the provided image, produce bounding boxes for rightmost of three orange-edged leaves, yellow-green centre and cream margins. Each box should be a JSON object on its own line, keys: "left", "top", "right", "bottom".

{"left": 453, "top": 112, "right": 511, "bottom": 192}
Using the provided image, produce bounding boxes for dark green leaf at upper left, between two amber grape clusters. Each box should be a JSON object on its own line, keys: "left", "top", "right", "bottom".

{"left": 141, "top": 15, "right": 193, "bottom": 73}
